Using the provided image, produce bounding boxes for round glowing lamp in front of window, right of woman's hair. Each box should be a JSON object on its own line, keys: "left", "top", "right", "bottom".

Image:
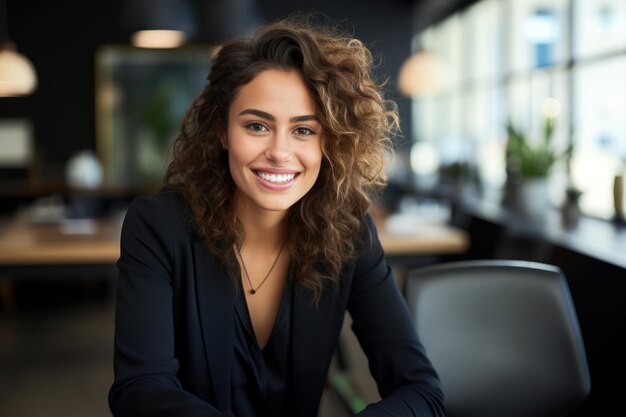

{"left": 398, "top": 49, "right": 445, "bottom": 98}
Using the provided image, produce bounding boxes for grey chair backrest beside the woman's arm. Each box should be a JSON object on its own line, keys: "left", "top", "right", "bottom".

{"left": 406, "top": 260, "right": 591, "bottom": 417}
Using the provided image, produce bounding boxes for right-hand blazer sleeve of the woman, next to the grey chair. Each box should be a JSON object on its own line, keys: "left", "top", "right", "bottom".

{"left": 348, "top": 217, "right": 445, "bottom": 417}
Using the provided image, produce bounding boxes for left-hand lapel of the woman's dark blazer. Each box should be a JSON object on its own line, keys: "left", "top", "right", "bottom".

{"left": 194, "top": 242, "right": 235, "bottom": 410}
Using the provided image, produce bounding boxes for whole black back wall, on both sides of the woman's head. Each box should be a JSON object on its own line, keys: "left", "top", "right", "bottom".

{"left": 0, "top": 0, "right": 412, "bottom": 180}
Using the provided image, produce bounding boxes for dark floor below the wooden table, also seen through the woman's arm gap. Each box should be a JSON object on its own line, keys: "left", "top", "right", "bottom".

{"left": 0, "top": 280, "right": 370, "bottom": 417}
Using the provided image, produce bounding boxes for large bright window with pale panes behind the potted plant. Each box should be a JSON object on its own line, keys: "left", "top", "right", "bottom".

{"left": 414, "top": 0, "right": 626, "bottom": 218}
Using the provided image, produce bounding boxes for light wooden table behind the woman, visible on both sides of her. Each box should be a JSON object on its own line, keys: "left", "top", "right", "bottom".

{"left": 0, "top": 211, "right": 468, "bottom": 305}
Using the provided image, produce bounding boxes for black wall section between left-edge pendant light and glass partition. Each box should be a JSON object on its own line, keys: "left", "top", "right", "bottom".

{"left": 0, "top": 0, "right": 128, "bottom": 179}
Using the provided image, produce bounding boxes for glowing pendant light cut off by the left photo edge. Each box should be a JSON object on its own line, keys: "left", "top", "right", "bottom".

{"left": 0, "top": 0, "right": 37, "bottom": 97}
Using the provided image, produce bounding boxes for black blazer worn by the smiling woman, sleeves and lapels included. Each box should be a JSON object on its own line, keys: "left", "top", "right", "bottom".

{"left": 109, "top": 191, "right": 444, "bottom": 417}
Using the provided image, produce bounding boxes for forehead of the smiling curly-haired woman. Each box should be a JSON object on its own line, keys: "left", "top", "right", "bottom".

{"left": 230, "top": 69, "right": 316, "bottom": 116}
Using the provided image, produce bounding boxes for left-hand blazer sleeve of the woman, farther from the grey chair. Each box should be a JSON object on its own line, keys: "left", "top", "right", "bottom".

{"left": 109, "top": 197, "right": 232, "bottom": 417}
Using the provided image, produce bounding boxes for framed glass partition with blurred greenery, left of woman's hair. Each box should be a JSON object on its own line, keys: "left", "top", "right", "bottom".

{"left": 96, "top": 46, "right": 211, "bottom": 187}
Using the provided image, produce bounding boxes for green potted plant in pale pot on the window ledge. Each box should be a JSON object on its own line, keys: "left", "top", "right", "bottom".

{"left": 506, "top": 117, "right": 572, "bottom": 220}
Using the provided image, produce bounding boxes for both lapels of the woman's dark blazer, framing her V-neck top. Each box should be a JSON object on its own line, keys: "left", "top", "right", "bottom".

{"left": 193, "top": 241, "right": 347, "bottom": 417}
